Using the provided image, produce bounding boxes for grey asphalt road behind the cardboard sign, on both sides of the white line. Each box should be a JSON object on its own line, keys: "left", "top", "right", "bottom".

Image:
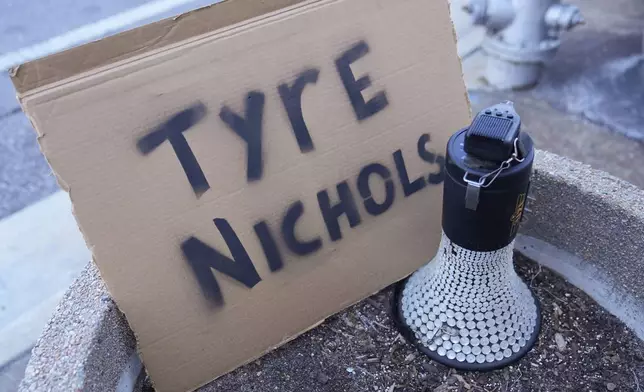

{"left": 0, "top": 0, "right": 215, "bottom": 219}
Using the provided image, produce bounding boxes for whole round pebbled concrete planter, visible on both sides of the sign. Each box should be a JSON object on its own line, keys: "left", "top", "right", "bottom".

{"left": 19, "top": 151, "right": 644, "bottom": 392}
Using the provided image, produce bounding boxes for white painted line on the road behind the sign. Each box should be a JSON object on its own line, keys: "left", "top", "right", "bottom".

{"left": 0, "top": 0, "right": 206, "bottom": 70}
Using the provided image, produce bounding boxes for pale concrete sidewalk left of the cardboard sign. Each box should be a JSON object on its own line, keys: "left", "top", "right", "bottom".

{"left": 0, "top": 191, "right": 91, "bottom": 391}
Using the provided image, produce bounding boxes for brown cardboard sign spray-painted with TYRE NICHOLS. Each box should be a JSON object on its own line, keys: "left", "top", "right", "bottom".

{"left": 14, "top": 0, "right": 469, "bottom": 392}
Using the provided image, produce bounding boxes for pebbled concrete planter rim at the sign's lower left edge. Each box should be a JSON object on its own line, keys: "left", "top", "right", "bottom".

{"left": 19, "top": 262, "right": 135, "bottom": 392}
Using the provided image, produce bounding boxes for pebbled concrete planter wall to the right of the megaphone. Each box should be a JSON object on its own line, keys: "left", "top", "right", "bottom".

{"left": 522, "top": 151, "right": 644, "bottom": 308}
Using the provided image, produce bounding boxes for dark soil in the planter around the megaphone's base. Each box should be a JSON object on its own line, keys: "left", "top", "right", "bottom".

{"left": 141, "top": 255, "right": 644, "bottom": 392}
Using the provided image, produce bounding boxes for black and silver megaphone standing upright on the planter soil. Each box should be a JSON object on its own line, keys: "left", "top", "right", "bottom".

{"left": 393, "top": 102, "right": 541, "bottom": 370}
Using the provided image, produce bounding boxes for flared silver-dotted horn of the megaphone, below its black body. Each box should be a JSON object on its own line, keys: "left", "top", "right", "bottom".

{"left": 393, "top": 233, "right": 541, "bottom": 370}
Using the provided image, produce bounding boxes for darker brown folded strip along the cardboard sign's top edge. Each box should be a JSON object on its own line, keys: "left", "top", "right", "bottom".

{"left": 9, "top": 0, "right": 305, "bottom": 95}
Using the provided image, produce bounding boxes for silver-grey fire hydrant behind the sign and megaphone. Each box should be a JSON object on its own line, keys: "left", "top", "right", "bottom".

{"left": 463, "top": 0, "right": 584, "bottom": 89}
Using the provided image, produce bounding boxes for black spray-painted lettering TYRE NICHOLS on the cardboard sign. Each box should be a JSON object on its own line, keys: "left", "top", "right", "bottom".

{"left": 137, "top": 41, "right": 445, "bottom": 306}
